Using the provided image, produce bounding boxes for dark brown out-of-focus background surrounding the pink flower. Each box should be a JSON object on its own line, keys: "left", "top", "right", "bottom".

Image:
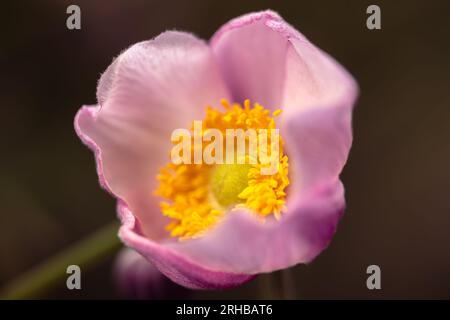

{"left": 0, "top": 0, "right": 450, "bottom": 299}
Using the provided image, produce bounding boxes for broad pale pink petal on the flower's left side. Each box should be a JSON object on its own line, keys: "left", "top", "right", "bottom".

{"left": 75, "top": 32, "right": 228, "bottom": 239}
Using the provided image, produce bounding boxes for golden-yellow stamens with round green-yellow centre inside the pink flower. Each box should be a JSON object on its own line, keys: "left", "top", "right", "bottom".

{"left": 156, "top": 100, "right": 289, "bottom": 240}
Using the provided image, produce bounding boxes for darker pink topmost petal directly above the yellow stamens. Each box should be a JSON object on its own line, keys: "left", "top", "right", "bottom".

{"left": 211, "top": 11, "right": 287, "bottom": 109}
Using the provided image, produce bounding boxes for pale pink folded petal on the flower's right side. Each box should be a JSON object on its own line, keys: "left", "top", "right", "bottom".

{"left": 281, "top": 33, "right": 358, "bottom": 193}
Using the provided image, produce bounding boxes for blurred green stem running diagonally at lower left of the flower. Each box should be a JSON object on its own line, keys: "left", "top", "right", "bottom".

{"left": 0, "top": 222, "right": 121, "bottom": 299}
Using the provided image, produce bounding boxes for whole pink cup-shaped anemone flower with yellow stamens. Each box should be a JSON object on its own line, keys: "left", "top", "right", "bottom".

{"left": 75, "top": 11, "right": 358, "bottom": 289}
